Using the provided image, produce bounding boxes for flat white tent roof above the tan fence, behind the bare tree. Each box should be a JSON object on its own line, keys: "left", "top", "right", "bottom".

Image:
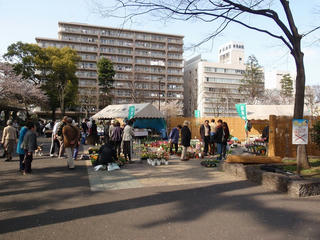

{"left": 247, "top": 105, "right": 311, "bottom": 120}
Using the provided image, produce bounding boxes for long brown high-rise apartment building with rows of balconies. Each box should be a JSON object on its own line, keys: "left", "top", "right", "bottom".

{"left": 36, "top": 22, "right": 183, "bottom": 112}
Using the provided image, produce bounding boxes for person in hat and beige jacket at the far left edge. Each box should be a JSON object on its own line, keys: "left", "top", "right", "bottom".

{"left": 1, "top": 120, "right": 17, "bottom": 161}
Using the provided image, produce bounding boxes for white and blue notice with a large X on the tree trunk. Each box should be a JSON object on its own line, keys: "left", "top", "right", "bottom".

{"left": 292, "top": 119, "right": 308, "bottom": 144}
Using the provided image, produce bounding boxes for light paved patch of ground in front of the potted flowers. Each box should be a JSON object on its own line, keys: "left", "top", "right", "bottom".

{"left": 87, "top": 156, "right": 230, "bottom": 191}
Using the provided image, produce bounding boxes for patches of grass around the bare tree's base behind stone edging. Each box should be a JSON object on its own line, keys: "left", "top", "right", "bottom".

{"left": 283, "top": 158, "right": 320, "bottom": 178}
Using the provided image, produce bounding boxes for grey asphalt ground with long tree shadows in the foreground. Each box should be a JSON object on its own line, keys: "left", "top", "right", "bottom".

{"left": 0, "top": 137, "right": 320, "bottom": 240}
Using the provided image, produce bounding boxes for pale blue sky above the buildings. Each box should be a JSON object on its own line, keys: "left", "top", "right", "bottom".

{"left": 0, "top": 0, "right": 320, "bottom": 88}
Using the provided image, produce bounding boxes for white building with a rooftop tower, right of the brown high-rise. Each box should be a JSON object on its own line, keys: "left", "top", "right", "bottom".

{"left": 184, "top": 42, "right": 256, "bottom": 117}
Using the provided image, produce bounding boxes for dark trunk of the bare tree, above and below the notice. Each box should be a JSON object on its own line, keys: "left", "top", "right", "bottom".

{"left": 293, "top": 40, "right": 310, "bottom": 174}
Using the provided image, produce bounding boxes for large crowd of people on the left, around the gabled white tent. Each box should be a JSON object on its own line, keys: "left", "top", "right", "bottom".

{"left": 1, "top": 116, "right": 134, "bottom": 175}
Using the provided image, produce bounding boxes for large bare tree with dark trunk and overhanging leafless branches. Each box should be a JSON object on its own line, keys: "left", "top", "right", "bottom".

{"left": 98, "top": 0, "right": 320, "bottom": 171}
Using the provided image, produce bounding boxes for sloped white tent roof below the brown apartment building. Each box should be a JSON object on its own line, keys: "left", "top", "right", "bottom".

{"left": 92, "top": 103, "right": 164, "bottom": 119}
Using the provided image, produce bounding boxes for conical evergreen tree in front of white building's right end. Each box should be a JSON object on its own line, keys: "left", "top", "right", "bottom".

{"left": 239, "top": 55, "right": 264, "bottom": 102}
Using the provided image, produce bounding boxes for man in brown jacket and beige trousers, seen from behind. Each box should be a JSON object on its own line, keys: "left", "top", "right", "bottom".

{"left": 62, "top": 118, "right": 80, "bottom": 169}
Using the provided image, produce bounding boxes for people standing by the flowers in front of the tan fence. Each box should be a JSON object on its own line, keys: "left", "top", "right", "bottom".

{"left": 169, "top": 119, "right": 230, "bottom": 161}
